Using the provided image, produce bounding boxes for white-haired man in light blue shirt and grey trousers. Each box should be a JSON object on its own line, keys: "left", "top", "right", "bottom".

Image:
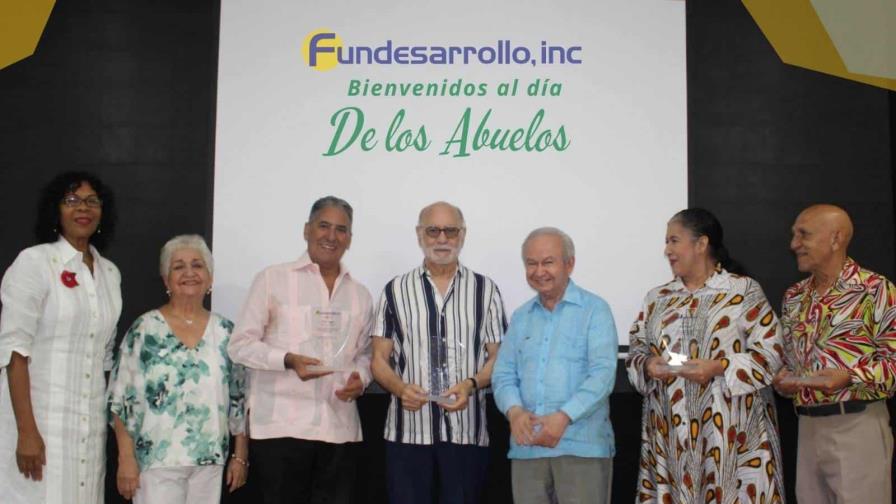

{"left": 492, "top": 228, "right": 617, "bottom": 504}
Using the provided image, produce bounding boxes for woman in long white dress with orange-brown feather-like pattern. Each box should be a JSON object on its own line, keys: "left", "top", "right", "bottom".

{"left": 626, "top": 208, "right": 784, "bottom": 503}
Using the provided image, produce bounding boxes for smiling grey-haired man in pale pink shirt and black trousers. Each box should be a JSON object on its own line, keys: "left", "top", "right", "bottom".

{"left": 228, "top": 196, "right": 373, "bottom": 504}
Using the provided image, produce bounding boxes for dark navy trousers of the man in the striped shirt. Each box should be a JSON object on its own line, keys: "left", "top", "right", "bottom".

{"left": 386, "top": 441, "right": 488, "bottom": 504}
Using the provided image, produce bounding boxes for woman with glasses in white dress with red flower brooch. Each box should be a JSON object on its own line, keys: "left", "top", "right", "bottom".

{"left": 0, "top": 172, "right": 121, "bottom": 504}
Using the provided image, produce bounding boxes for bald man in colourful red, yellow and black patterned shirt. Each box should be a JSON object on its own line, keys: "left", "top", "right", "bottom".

{"left": 775, "top": 205, "right": 896, "bottom": 504}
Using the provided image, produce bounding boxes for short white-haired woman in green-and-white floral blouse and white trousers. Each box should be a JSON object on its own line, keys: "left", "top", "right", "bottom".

{"left": 109, "top": 235, "right": 249, "bottom": 504}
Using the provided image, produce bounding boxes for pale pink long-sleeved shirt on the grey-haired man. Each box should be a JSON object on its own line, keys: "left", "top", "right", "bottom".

{"left": 228, "top": 252, "right": 373, "bottom": 443}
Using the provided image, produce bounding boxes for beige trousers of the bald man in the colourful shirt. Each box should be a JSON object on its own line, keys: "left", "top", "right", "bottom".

{"left": 796, "top": 401, "right": 893, "bottom": 504}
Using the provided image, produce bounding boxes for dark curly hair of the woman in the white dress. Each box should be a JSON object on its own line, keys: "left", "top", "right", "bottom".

{"left": 34, "top": 171, "right": 117, "bottom": 249}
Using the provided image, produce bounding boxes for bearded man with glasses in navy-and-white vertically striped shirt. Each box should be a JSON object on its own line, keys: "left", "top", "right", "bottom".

{"left": 371, "top": 202, "right": 507, "bottom": 504}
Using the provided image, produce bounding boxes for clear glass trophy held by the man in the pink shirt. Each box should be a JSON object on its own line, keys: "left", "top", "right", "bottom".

{"left": 299, "top": 308, "right": 354, "bottom": 373}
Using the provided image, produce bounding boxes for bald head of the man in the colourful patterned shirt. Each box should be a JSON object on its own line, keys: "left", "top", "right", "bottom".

{"left": 790, "top": 205, "right": 853, "bottom": 275}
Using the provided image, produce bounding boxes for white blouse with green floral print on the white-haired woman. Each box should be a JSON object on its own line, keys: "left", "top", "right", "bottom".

{"left": 108, "top": 310, "right": 246, "bottom": 471}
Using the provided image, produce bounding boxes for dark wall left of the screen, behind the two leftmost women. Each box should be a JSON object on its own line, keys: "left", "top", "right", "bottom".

{"left": 0, "top": 0, "right": 219, "bottom": 332}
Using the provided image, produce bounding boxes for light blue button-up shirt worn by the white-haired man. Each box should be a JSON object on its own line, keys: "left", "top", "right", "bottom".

{"left": 492, "top": 280, "right": 618, "bottom": 459}
